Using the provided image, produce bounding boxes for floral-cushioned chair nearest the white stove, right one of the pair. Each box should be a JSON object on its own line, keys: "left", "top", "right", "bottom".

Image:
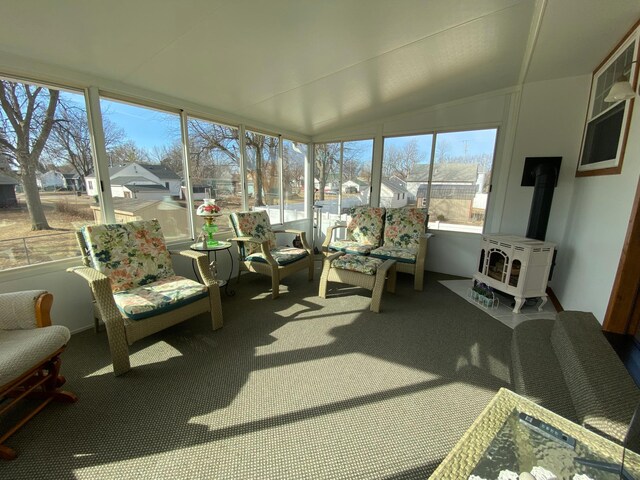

{"left": 370, "top": 207, "right": 430, "bottom": 291}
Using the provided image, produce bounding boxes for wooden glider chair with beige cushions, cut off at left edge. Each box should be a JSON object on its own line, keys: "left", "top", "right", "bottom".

{"left": 0, "top": 290, "right": 78, "bottom": 460}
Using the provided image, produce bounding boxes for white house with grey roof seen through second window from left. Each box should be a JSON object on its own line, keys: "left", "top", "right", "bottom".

{"left": 85, "top": 163, "right": 182, "bottom": 200}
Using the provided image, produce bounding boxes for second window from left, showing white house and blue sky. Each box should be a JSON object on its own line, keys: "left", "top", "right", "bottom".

{"left": 98, "top": 98, "right": 191, "bottom": 240}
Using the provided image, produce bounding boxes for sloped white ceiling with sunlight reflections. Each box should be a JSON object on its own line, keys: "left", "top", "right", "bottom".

{"left": 0, "top": 0, "right": 640, "bottom": 136}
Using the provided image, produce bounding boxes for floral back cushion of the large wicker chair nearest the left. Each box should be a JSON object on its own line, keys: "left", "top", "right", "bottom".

{"left": 82, "top": 220, "right": 175, "bottom": 293}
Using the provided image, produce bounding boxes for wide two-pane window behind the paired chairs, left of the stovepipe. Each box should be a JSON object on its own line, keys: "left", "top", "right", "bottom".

{"left": 380, "top": 129, "right": 497, "bottom": 233}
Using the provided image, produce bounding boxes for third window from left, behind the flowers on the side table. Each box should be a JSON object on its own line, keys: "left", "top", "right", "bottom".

{"left": 189, "top": 118, "right": 243, "bottom": 231}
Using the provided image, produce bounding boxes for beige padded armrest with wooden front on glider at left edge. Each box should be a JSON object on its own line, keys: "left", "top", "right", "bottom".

{"left": 0, "top": 290, "right": 53, "bottom": 330}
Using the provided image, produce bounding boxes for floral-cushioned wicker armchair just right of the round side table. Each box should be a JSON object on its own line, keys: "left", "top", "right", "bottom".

{"left": 230, "top": 211, "right": 313, "bottom": 299}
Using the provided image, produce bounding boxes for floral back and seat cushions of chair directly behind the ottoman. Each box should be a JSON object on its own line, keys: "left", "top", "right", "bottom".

{"left": 322, "top": 205, "right": 385, "bottom": 255}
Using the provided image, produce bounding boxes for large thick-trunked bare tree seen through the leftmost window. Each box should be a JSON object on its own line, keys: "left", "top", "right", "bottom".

{"left": 0, "top": 80, "right": 60, "bottom": 230}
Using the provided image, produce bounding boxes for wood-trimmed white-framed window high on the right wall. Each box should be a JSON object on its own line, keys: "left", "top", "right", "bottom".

{"left": 576, "top": 24, "right": 640, "bottom": 177}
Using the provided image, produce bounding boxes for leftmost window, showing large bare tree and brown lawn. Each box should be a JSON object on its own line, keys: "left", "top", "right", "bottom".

{"left": 0, "top": 80, "right": 95, "bottom": 270}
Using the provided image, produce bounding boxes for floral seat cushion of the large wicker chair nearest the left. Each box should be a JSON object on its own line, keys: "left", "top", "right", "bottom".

{"left": 113, "top": 276, "right": 209, "bottom": 320}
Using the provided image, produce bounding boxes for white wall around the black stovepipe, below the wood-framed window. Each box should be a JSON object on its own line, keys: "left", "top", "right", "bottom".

{"left": 510, "top": 75, "right": 640, "bottom": 323}
